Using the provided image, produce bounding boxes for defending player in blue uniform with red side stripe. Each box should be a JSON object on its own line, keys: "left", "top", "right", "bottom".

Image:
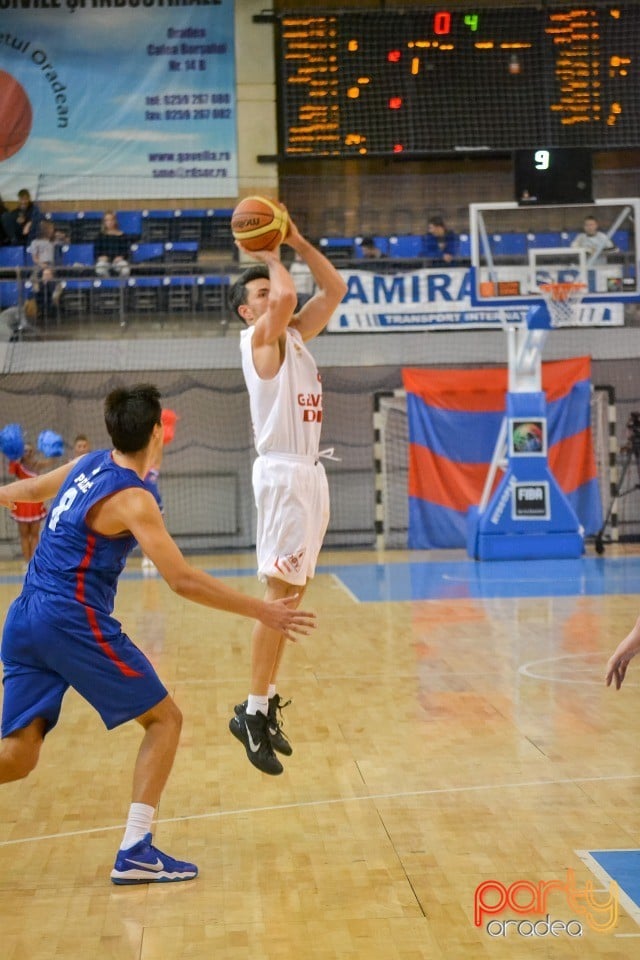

{"left": 0, "top": 384, "right": 315, "bottom": 884}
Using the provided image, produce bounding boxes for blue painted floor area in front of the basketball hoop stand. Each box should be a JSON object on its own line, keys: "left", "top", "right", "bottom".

{"left": 318, "top": 557, "right": 640, "bottom": 603}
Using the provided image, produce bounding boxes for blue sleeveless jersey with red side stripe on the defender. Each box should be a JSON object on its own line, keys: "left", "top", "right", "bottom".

{"left": 23, "top": 450, "right": 151, "bottom": 614}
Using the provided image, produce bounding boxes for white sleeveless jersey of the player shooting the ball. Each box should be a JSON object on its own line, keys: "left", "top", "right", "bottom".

{"left": 240, "top": 327, "right": 322, "bottom": 457}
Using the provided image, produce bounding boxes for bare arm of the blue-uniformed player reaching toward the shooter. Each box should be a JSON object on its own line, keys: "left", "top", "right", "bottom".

{"left": 118, "top": 489, "right": 316, "bottom": 640}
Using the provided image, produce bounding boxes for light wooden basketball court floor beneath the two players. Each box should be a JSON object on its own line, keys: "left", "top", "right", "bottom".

{"left": 0, "top": 548, "right": 640, "bottom": 960}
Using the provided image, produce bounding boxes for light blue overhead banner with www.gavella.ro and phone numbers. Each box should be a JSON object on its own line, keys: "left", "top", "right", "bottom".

{"left": 0, "top": 0, "right": 237, "bottom": 201}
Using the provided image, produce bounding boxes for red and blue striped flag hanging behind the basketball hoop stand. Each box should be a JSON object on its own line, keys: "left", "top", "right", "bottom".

{"left": 402, "top": 357, "right": 602, "bottom": 550}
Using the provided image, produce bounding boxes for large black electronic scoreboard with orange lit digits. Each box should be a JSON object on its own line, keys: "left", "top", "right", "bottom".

{"left": 276, "top": 0, "right": 640, "bottom": 159}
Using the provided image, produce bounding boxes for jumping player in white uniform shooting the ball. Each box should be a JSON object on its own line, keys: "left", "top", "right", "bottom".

{"left": 229, "top": 210, "right": 347, "bottom": 774}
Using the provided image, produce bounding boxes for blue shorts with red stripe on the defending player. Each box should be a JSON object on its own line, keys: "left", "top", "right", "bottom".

{"left": 0, "top": 592, "right": 167, "bottom": 737}
